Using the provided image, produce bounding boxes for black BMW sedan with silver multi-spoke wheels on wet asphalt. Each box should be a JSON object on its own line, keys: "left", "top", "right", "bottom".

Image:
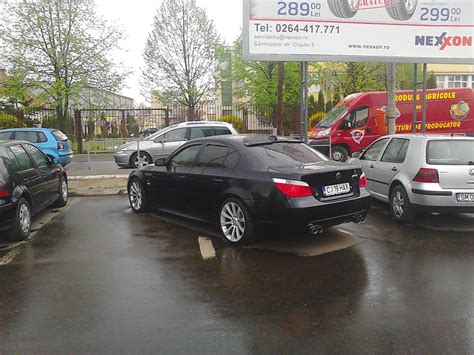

{"left": 128, "top": 135, "right": 370, "bottom": 244}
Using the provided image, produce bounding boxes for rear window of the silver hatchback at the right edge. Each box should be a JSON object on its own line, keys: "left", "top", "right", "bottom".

{"left": 426, "top": 140, "right": 474, "bottom": 165}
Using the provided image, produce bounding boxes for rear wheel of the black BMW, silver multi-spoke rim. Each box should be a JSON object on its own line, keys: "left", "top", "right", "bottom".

{"left": 219, "top": 198, "right": 256, "bottom": 245}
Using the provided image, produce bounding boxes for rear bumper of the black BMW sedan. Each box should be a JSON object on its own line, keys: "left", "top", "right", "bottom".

{"left": 250, "top": 190, "right": 371, "bottom": 227}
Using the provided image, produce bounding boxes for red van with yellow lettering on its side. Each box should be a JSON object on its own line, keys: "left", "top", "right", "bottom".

{"left": 308, "top": 88, "right": 474, "bottom": 161}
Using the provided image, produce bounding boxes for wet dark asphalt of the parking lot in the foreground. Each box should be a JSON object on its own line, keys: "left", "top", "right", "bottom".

{"left": 0, "top": 197, "right": 474, "bottom": 354}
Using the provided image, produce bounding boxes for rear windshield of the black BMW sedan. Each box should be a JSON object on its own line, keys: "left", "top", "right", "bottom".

{"left": 249, "top": 142, "right": 327, "bottom": 167}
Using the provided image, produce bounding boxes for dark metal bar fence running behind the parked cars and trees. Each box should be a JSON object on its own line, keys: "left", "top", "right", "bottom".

{"left": 0, "top": 104, "right": 320, "bottom": 154}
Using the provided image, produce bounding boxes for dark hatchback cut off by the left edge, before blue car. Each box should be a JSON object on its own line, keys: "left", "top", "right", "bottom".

{"left": 0, "top": 141, "right": 68, "bottom": 241}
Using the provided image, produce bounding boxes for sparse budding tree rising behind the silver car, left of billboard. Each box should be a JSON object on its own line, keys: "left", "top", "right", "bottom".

{"left": 142, "top": 0, "right": 221, "bottom": 120}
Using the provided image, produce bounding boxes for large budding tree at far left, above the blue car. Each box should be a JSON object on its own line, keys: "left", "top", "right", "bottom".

{"left": 0, "top": 0, "right": 124, "bottom": 128}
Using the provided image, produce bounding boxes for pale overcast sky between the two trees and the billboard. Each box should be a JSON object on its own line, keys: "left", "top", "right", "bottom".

{"left": 97, "top": 0, "right": 243, "bottom": 104}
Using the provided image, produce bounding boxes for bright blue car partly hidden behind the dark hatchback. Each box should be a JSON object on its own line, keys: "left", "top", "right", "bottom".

{"left": 0, "top": 128, "right": 74, "bottom": 166}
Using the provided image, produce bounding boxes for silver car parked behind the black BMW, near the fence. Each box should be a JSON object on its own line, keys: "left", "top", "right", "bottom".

{"left": 115, "top": 121, "right": 238, "bottom": 168}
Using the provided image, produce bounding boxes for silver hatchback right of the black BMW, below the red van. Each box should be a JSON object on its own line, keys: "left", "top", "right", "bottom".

{"left": 349, "top": 134, "right": 474, "bottom": 221}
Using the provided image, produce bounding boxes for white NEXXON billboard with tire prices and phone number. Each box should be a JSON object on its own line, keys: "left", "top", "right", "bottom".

{"left": 243, "top": 0, "right": 474, "bottom": 64}
